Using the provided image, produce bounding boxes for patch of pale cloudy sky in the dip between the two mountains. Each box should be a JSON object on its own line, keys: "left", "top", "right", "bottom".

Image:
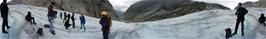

{"left": 109, "top": 0, "right": 141, "bottom": 12}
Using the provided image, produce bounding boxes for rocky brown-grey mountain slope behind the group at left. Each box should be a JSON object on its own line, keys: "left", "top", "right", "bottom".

{"left": 9, "top": 0, "right": 118, "bottom": 19}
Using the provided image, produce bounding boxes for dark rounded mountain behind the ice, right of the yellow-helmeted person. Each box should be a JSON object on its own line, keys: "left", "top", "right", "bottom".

{"left": 122, "top": 0, "right": 229, "bottom": 22}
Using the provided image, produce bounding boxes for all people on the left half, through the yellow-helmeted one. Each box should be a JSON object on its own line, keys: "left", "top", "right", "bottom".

{"left": 0, "top": 0, "right": 112, "bottom": 39}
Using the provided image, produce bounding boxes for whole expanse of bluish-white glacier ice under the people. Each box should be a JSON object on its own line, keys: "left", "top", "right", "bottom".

{"left": 0, "top": 5, "right": 266, "bottom": 39}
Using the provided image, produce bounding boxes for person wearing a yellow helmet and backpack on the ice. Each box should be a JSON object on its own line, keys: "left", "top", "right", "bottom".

{"left": 100, "top": 10, "right": 112, "bottom": 39}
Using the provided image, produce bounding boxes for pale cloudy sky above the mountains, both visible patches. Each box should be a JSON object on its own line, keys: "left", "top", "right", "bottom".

{"left": 109, "top": 0, "right": 258, "bottom": 12}
